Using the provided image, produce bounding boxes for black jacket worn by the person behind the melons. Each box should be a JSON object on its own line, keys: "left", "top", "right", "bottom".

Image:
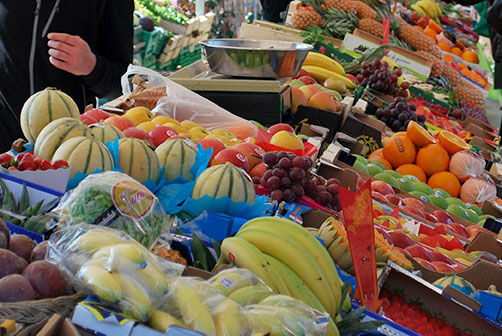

{"left": 0, "top": 0, "right": 134, "bottom": 151}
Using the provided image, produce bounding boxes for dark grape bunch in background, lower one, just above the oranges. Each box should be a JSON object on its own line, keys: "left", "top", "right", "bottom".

{"left": 376, "top": 97, "right": 427, "bottom": 132}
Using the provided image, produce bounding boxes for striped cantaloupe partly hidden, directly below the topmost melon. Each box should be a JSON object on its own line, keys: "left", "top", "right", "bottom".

{"left": 34, "top": 117, "right": 91, "bottom": 161}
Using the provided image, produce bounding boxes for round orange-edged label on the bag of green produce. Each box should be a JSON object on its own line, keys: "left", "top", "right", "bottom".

{"left": 112, "top": 181, "right": 155, "bottom": 219}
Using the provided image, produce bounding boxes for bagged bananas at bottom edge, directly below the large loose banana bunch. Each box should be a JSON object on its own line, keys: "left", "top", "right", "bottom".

{"left": 244, "top": 295, "right": 329, "bottom": 335}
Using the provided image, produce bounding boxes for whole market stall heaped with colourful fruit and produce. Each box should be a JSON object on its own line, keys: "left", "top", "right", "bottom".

{"left": 0, "top": 0, "right": 502, "bottom": 336}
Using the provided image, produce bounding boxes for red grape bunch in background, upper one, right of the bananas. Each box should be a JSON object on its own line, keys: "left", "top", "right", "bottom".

{"left": 357, "top": 60, "right": 410, "bottom": 97}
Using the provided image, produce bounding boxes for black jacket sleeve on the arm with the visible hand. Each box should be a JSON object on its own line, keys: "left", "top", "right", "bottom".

{"left": 83, "top": 0, "right": 134, "bottom": 98}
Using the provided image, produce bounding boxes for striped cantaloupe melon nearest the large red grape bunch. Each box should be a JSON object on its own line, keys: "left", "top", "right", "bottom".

{"left": 192, "top": 162, "right": 256, "bottom": 205}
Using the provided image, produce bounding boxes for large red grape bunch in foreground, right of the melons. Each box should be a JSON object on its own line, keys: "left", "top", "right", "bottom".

{"left": 253, "top": 152, "right": 340, "bottom": 210}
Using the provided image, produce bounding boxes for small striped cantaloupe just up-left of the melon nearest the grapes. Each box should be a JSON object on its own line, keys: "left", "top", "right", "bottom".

{"left": 155, "top": 139, "right": 196, "bottom": 181}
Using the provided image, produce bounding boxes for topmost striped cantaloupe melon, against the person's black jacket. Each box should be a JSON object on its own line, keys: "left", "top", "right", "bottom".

{"left": 21, "top": 88, "right": 80, "bottom": 143}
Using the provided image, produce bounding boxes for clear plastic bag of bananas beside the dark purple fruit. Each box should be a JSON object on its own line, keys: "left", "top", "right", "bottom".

{"left": 48, "top": 224, "right": 184, "bottom": 321}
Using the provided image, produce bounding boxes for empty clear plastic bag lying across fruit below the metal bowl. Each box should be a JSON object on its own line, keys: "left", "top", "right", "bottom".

{"left": 122, "top": 65, "right": 257, "bottom": 139}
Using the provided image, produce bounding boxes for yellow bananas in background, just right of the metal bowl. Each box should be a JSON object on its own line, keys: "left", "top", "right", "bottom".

{"left": 302, "top": 51, "right": 356, "bottom": 90}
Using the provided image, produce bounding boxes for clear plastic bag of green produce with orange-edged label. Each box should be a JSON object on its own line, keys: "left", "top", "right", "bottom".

{"left": 53, "top": 171, "right": 170, "bottom": 248}
